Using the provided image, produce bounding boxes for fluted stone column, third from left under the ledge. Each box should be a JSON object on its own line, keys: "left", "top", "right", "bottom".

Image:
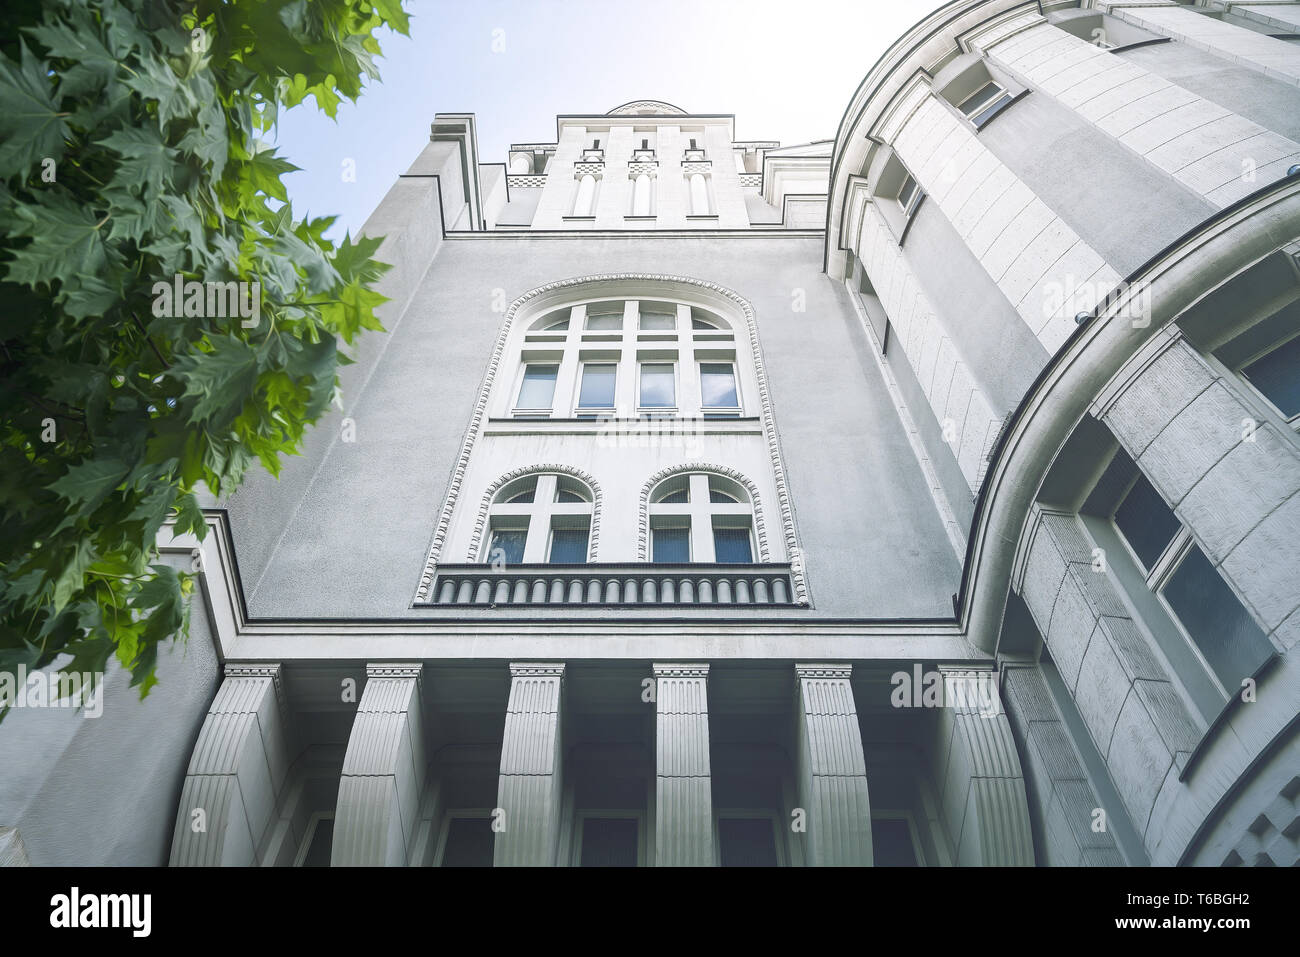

{"left": 493, "top": 662, "right": 564, "bottom": 867}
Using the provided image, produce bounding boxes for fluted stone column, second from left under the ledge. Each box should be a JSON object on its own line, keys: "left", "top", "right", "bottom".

{"left": 330, "top": 664, "right": 429, "bottom": 867}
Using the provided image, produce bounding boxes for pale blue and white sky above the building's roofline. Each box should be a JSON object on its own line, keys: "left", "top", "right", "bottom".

{"left": 277, "top": 0, "right": 940, "bottom": 239}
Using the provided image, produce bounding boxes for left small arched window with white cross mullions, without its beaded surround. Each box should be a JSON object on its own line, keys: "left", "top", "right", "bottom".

{"left": 480, "top": 471, "right": 595, "bottom": 566}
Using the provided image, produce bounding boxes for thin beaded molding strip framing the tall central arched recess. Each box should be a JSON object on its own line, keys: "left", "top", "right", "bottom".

{"left": 415, "top": 273, "right": 810, "bottom": 605}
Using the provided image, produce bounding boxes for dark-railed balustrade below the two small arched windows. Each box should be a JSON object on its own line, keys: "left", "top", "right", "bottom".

{"left": 426, "top": 562, "right": 794, "bottom": 607}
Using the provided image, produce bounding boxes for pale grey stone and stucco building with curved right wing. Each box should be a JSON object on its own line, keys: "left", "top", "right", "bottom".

{"left": 0, "top": 0, "right": 1300, "bottom": 866}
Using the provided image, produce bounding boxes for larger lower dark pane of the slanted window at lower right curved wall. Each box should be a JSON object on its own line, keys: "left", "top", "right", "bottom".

{"left": 1162, "top": 545, "right": 1273, "bottom": 696}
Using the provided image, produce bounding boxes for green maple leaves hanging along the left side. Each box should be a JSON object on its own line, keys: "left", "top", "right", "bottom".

{"left": 0, "top": 0, "right": 407, "bottom": 716}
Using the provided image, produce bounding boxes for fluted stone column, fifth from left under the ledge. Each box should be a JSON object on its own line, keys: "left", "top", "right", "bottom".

{"left": 794, "top": 664, "right": 874, "bottom": 867}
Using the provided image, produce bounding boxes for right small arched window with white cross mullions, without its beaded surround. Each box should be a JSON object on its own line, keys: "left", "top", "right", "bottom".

{"left": 649, "top": 472, "right": 758, "bottom": 564}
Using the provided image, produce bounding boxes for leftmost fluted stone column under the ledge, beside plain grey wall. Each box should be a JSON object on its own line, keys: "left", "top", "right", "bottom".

{"left": 170, "top": 664, "right": 293, "bottom": 867}
